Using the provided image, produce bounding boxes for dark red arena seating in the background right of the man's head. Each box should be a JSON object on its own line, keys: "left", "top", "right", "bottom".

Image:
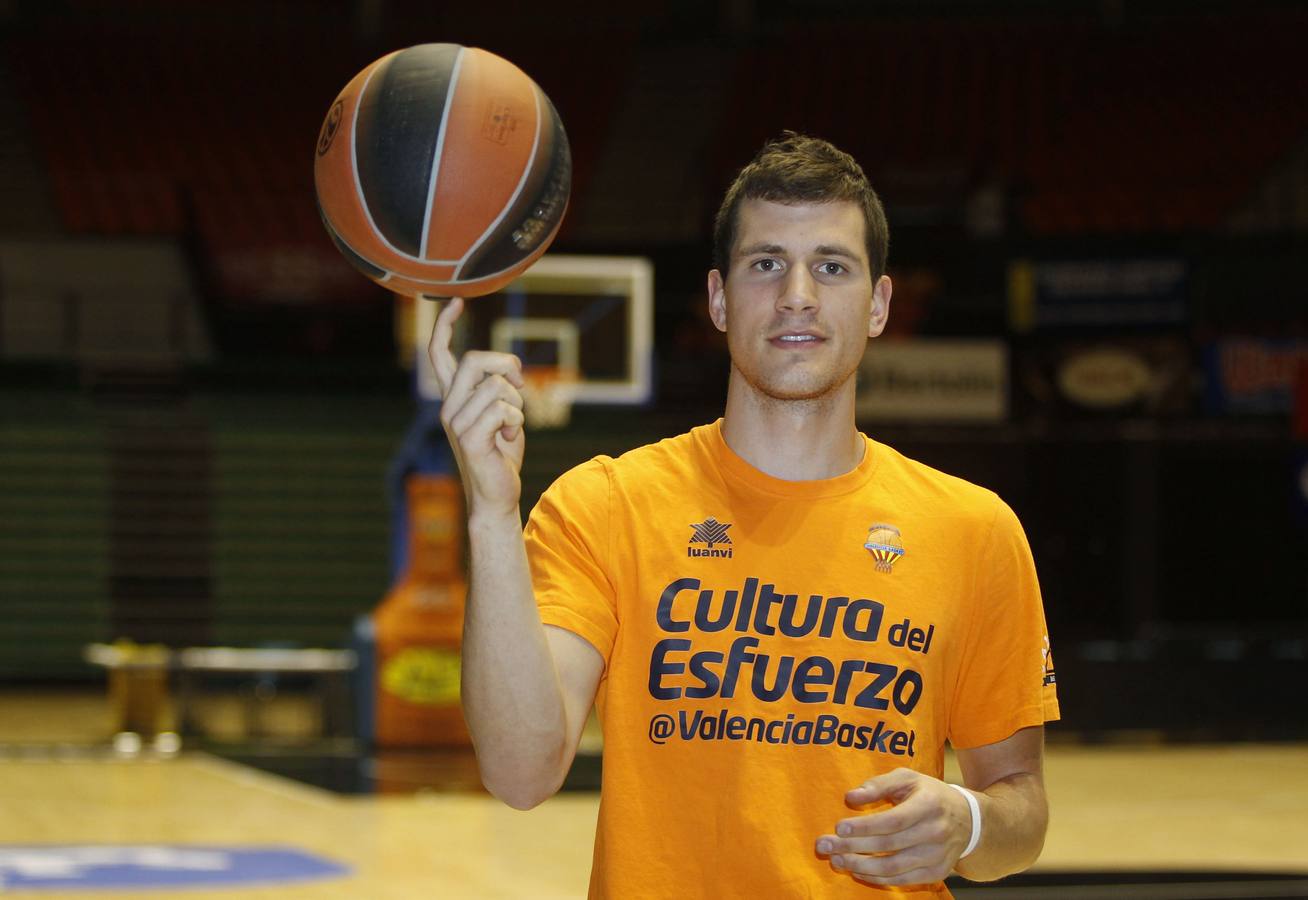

{"left": 714, "top": 17, "right": 1308, "bottom": 234}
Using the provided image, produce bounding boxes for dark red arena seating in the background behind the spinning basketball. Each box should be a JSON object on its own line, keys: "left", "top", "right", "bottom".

{"left": 7, "top": 17, "right": 630, "bottom": 301}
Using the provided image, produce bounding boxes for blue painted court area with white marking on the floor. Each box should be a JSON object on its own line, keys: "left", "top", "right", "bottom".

{"left": 0, "top": 844, "right": 351, "bottom": 893}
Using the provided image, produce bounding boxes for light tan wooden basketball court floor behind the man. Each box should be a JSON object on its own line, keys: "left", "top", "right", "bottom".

{"left": 0, "top": 719, "right": 1308, "bottom": 900}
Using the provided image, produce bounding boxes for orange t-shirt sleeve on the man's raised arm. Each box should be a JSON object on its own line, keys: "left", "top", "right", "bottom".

{"left": 525, "top": 458, "right": 617, "bottom": 670}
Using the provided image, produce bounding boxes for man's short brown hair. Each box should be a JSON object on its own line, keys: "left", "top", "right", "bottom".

{"left": 713, "top": 131, "right": 889, "bottom": 281}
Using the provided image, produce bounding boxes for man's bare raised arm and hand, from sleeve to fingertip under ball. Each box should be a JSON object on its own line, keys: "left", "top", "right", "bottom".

{"left": 429, "top": 298, "right": 603, "bottom": 810}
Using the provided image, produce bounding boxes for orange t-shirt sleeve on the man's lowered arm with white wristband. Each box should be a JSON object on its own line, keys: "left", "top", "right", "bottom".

{"left": 950, "top": 498, "right": 1058, "bottom": 748}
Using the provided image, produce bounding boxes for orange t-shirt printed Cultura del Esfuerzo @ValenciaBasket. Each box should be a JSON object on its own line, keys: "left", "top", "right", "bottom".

{"left": 526, "top": 421, "right": 1058, "bottom": 900}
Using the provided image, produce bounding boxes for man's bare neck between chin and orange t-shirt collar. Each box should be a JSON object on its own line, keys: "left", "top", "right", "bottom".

{"left": 722, "top": 372, "right": 866, "bottom": 481}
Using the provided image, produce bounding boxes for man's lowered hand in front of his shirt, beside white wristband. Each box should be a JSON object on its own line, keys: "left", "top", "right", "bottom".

{"left": 818, "top": 768, "right": 972, "bottom": 884}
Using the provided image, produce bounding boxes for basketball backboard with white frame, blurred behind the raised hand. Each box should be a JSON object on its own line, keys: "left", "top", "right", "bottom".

{"left": 413, "top": 254, "right": 654, "bottom": 406}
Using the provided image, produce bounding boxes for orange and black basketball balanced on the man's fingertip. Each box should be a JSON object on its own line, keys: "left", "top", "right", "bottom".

{"left": 314, "top": 43, "right": 572, "bottom": 297}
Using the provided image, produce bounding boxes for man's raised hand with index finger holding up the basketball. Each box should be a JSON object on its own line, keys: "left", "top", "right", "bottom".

{"left": 428, "top": 297, "right": 526, "bottom": 518}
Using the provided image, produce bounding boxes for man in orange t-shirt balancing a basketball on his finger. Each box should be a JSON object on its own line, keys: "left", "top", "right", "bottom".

{"left": 432, "top": 132, "right": 1058, "bottom": 900}
